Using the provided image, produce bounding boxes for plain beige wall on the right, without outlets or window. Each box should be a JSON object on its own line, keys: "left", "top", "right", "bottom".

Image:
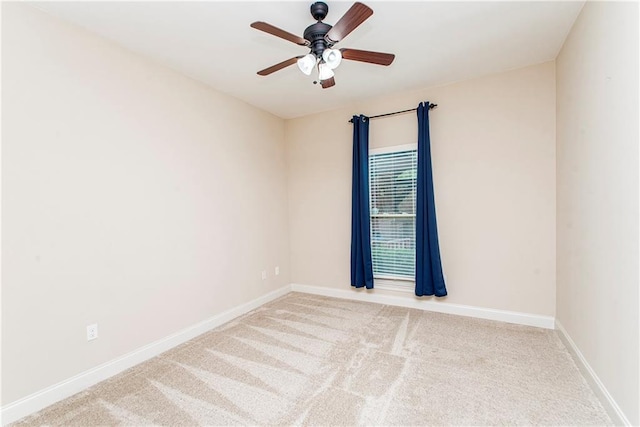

{"left": 556, "top": 2, "right": 640, "bottom": 425}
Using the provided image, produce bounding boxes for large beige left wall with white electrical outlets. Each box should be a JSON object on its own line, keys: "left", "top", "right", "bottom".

{"left": 2, "top": 2, "right": 290, "bottom": 404}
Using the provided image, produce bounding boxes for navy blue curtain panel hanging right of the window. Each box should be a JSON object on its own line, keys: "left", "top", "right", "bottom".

{"left": 416, "top": 102, "right": 447, "bottom": 297}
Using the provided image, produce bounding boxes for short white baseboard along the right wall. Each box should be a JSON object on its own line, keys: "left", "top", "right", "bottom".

{"left": 556, "top": 320, "right": 631, "bottom": 426}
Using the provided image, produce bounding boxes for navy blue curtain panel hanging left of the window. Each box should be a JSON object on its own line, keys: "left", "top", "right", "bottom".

{"left": 351, "top": 115, "right": 373, "bottom": 289}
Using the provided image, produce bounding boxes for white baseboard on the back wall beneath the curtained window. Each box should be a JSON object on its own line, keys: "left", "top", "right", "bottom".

{"left": 291, "top": 283, "right": 555, "bottom": 329}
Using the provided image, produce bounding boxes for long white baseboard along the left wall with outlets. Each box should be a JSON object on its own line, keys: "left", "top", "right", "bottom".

{"left": 0, "top": 285, "right": 291, "bottom": 426}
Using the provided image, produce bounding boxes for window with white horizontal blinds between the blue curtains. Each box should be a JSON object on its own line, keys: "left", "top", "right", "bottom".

{"left": 369, "top": 144, "right": 418, "bottom": 280}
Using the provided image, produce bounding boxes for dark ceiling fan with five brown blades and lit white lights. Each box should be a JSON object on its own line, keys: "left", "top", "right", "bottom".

{"left": 251, "top": 1, "right": 395, "bottom": 89}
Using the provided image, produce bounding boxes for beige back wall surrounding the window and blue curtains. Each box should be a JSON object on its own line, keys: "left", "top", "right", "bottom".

{"left": 286, "top": 62, "right": 556, "bottom": 316}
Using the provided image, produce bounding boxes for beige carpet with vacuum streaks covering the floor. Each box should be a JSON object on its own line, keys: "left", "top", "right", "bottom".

{"left": 17, "top": 293, "right": 611, "bottom": 426}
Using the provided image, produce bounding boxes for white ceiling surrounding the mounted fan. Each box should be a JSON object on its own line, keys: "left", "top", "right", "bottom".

{"left": 32, "top": 0, "right": 584, "bottom": 118}
